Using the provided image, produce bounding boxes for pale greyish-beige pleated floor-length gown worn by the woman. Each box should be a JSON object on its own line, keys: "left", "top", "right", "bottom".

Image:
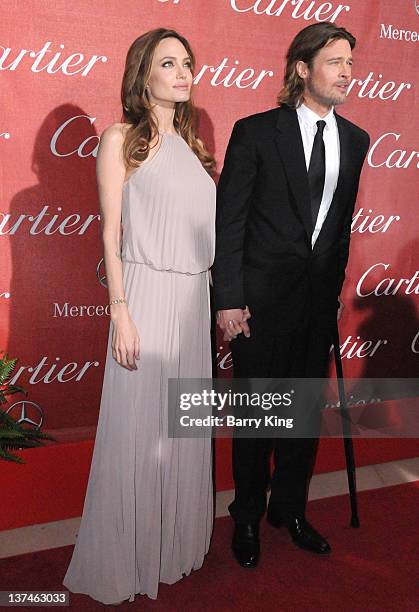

{"left": 63, "top": 134, "right": 215, "bottom": 603}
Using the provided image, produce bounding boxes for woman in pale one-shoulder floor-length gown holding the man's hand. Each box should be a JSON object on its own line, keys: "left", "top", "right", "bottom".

{"left": 63, "top": 29, "right": 215, "bottom": 603}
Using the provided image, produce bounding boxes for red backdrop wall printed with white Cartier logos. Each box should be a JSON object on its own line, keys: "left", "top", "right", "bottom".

{"left": 0, "top": 0, "right": 419, "bottom": 478}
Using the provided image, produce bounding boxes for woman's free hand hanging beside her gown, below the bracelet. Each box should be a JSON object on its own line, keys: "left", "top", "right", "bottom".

{"left": 111, "top": 304, "right": 140, "bottom": 370}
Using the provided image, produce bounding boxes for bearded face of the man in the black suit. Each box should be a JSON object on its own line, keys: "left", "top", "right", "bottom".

{"left": 303, "top": 39, "right": 352, "bottom": 107}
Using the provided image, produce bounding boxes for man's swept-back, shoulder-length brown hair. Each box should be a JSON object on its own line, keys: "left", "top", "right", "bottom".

{"left": 278, "top": 22, "right": 356, "bottom": 108}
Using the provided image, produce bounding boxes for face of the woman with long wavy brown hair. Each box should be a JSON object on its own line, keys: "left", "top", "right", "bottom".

{"left": 147, "top": 38, "right": 192, "bottom": 107}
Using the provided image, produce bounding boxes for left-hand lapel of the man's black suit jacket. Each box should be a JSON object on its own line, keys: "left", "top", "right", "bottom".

{"left": 275, "top": 106, "right": 313, "bottom": 242}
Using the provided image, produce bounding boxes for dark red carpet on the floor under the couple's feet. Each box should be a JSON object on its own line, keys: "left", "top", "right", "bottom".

{"left": 0, "top": 481, "right": 419, "bottom": 612}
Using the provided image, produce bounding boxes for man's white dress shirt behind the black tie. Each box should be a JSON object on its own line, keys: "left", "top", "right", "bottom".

{"left": 297, "top": 104, "right": 340, "bottom": 248}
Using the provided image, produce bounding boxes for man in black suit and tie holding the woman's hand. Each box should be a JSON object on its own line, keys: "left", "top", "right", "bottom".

{"left": 212, "top": 22, "right": 369, "bottom": 567}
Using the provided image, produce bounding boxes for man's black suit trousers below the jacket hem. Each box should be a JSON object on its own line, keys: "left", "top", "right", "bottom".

{"left": 229, "top": 317, "right": 333, "bottom": 523}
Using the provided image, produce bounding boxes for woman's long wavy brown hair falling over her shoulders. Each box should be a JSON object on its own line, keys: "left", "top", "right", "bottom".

{"left": 121, "top": 28, "right": 215, "bottom": 171}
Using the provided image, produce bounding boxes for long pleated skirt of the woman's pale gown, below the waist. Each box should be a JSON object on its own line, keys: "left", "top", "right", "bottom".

{"left": 63, "top": 262, "right": 213, "bottom": 603}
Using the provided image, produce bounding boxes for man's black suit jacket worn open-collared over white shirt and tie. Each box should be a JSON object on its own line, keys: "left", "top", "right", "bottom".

{"left": 212, "top": 106, "right": 369, "bottom": 330}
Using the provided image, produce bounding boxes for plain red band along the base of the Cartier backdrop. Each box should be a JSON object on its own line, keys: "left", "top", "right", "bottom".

{"left": 0, "top": 438, "right": 419, "bottom": 531}
